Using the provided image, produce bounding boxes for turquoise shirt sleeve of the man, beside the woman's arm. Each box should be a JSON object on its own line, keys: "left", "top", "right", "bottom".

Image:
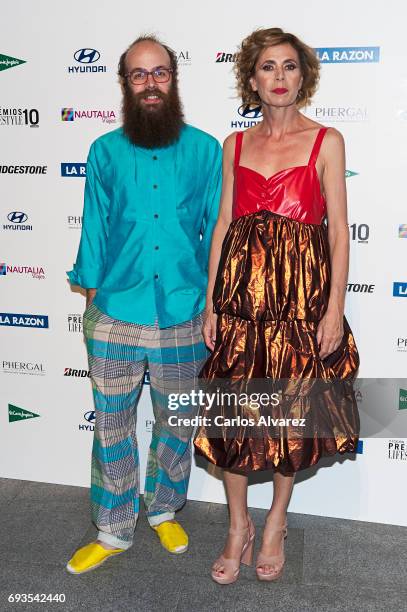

{"left": 200, "top": 141, "right": 222, "bottom": 271}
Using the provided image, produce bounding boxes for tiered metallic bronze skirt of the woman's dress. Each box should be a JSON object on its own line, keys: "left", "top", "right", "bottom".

{"left": 194, "top": 211, "right": 359, "bottom": 473}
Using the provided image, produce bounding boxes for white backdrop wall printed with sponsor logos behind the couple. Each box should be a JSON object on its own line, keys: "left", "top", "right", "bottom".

{"left": 0, "top": 0, "right": 407, "bottom": 525}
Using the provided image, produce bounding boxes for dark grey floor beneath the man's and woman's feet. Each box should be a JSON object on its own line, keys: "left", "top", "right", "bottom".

{"left": 0, "top": 479, "right": 407, "bottom": 612}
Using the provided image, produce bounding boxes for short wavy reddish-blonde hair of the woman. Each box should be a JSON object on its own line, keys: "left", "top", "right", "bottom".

{"left": 235, "top": 28, "right": 320, "bottom": 108}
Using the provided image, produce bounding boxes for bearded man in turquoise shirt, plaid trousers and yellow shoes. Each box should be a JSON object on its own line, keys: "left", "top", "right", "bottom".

{"left": 67, "top": 36, "right": 221, "bottom": 574}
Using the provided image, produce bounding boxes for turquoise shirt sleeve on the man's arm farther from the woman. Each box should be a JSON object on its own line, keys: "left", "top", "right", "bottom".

{"left": 67, "top": 143, "right": 110, "bottom": 289}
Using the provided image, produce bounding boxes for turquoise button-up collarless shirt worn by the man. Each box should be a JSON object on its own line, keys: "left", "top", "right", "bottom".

{"left": 68, "top": 125, "right": 222, "bottom": 328}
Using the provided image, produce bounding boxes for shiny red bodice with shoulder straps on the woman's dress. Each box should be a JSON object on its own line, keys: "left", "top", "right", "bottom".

{"left": 233, "top": 128, "right": 328, "bottom": 225}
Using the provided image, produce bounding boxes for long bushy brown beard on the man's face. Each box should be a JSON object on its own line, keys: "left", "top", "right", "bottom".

{"left": 122, "top": 82, "right": 184, "bottom": 149}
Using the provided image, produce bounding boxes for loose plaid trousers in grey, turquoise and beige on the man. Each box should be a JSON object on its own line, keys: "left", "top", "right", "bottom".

{"left": 83, "top": 304, "right": 208, "bottom": 548}
